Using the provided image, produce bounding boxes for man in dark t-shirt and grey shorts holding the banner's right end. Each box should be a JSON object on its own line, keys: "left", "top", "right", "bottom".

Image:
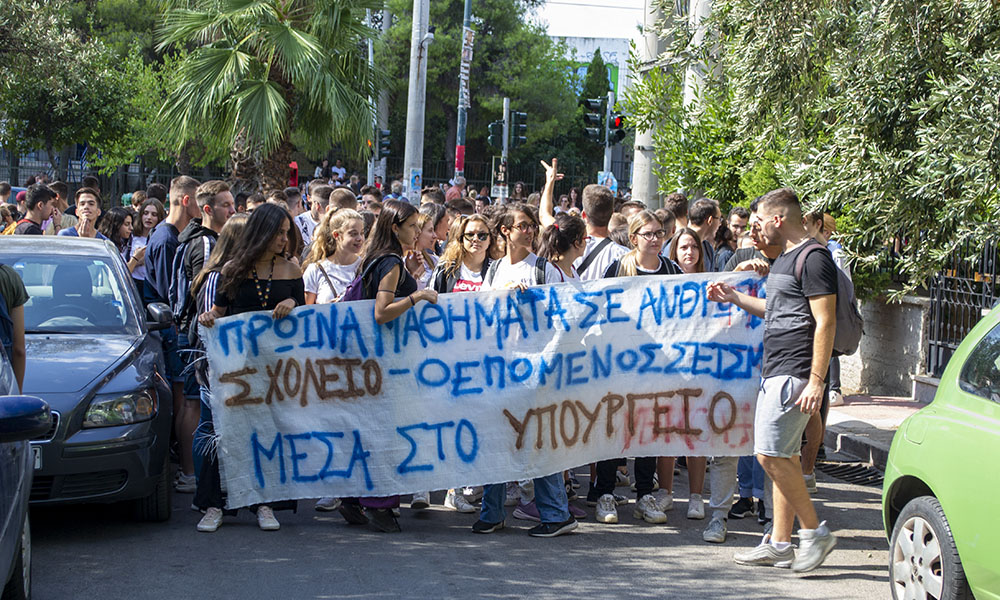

{"left": 708, "top": 188, "right": 838, "bottom": 573}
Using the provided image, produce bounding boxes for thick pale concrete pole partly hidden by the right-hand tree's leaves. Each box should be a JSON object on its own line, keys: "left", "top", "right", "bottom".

{"left": 632, "top": 0, "right": 677, "bottom": 209}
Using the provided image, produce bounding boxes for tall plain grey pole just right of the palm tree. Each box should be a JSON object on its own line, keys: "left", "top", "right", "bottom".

{"left": 403, "top": 0, "right": 434, "bottom": 203}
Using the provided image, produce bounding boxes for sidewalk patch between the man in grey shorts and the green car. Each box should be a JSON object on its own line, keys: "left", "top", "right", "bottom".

{"left": 823, "top": 396, "right": 926, "bottom": 471}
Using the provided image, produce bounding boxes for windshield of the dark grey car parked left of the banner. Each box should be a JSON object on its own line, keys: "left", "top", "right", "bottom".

{"left": 0, "top": 254, "right": 141, "bottom": 335}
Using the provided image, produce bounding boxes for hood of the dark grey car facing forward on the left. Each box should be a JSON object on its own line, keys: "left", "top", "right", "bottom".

{"left": 24, "top": 334, "right": 139, "bottom": 394}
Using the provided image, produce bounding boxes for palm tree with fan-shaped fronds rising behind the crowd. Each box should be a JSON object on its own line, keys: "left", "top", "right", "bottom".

{"left": 158, "top": 0, "right": 383, "bottom": 189}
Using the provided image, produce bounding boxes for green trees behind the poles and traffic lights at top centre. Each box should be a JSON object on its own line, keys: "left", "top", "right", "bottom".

{"left": 376, "top": 0, "right": 576, "bottom": 173}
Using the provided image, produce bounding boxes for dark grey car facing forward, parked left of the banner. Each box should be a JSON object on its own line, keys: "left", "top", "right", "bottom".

{"left": 0, "top": 236, "right": 172, "bottom": 521}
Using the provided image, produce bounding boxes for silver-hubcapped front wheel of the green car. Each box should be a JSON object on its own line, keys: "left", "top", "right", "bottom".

{"left": 889, "top": 496, "right": 972, "bottom": 600}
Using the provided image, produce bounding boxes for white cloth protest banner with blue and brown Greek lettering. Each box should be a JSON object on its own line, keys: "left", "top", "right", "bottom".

{"left": 201, "top": 273, "right": 763, "bottom": 507}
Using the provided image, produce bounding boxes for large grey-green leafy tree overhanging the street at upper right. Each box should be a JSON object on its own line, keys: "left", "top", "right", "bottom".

{"left": 632, "top": 0, "right": 1000, "bottom": 294}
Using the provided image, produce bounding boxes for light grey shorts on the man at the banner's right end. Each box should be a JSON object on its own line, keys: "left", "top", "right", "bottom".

{"left": 753, "top": 375, "right": 810, "bottom": 458}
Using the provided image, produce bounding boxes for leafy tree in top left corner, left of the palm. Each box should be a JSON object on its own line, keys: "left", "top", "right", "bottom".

{"left": 0, "top": 0, "right": 141, "bottom": 164}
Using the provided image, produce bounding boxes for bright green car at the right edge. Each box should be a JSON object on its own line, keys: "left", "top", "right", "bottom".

{"left": 882, "top": 308, "right": 1000, "bottom": 600}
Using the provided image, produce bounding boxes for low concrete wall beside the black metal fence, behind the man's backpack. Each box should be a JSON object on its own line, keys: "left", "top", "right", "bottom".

{"left": 840, "top": 296, "right": 930, "bottom": 397}
